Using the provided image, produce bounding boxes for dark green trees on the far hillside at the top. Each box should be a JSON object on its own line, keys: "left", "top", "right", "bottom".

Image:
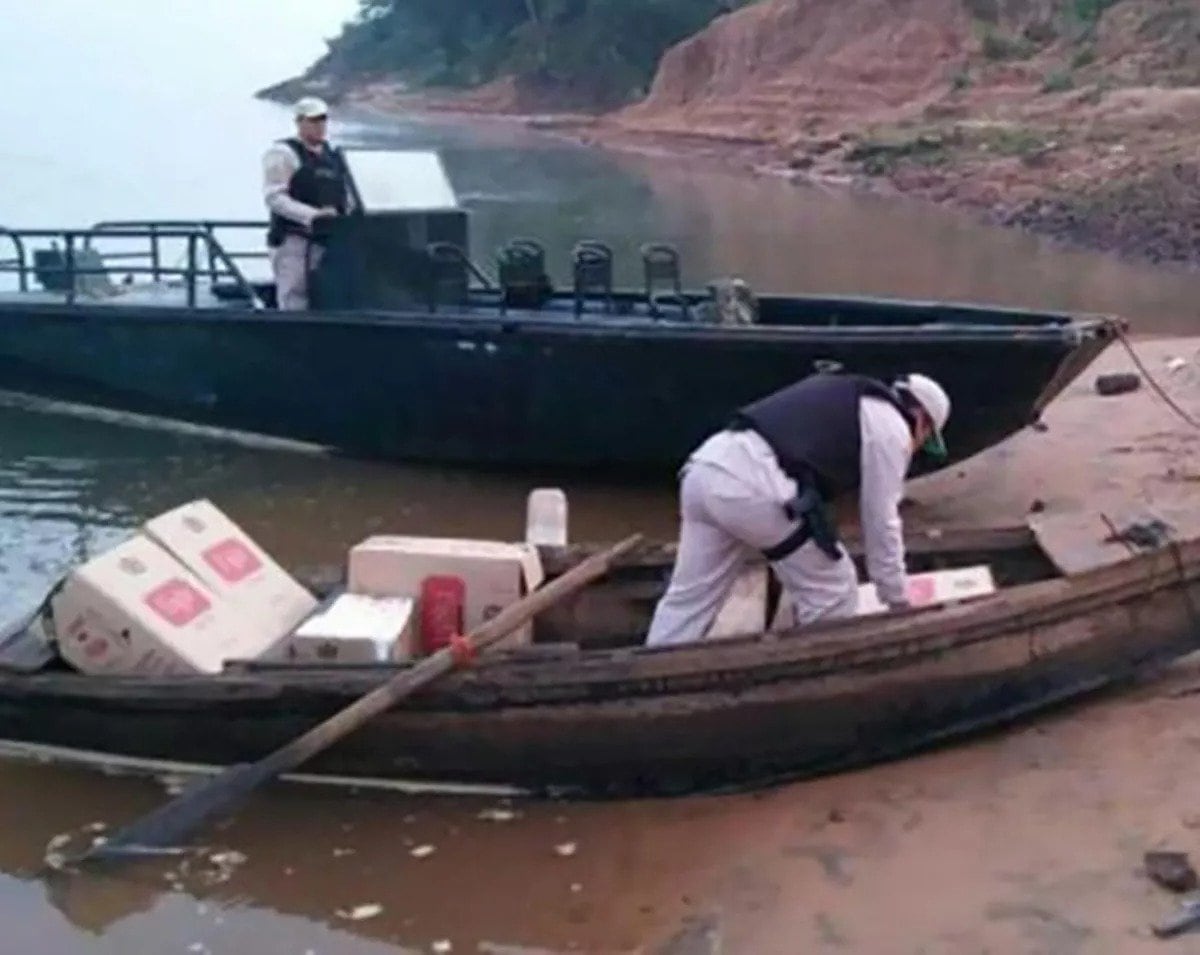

{"left": 308, "top": 0, "right": 746, "bottom": 106}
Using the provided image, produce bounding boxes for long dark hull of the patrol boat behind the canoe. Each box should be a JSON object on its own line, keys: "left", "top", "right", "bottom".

{"left": 0, "top": 294, "right": 1114, "bottom": 476}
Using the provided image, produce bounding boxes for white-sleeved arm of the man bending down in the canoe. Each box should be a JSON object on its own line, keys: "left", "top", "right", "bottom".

{"left": 858, "top": 397, "right": 912, "bottom": 609}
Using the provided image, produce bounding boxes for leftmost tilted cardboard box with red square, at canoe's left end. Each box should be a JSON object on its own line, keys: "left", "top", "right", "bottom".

{"left": 50, "top": 534, "right": 261, "bottom": 675}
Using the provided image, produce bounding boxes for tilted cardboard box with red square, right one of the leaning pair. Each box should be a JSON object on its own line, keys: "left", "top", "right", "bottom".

{"left": 143, "top": 500, "right": 317, "bottom": 638}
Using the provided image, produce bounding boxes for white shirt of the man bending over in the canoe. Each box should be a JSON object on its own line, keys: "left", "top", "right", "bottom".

{"left": 691, "top": 396, "right": 912, "bottom": 605}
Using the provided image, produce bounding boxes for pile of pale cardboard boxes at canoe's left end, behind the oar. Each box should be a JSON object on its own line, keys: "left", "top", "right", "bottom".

{"left": 43, "top": 500, "right": 542, "bottom": 677}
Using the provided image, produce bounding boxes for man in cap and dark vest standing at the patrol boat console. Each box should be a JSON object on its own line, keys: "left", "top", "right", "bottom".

{"left": 263, "top": 96, "right": 353, "bottom": 311}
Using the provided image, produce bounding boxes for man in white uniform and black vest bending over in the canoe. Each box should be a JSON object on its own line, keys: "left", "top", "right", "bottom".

{"left": 646, "top": 373, "right": 950, "bottom": 647}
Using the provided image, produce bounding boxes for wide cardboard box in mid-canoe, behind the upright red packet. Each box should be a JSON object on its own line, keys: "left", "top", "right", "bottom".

{"left": 347, "top": 535, "right": 544, "bottom": 645}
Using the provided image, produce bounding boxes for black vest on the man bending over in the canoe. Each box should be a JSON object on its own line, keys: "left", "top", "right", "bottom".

{"left": 734, "top": 372, "right": 914, "bottom": 499}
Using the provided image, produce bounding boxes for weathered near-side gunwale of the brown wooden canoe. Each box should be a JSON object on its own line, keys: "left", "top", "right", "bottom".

{"left": 11, "top": 541, "right": 1200, "bottom": 711}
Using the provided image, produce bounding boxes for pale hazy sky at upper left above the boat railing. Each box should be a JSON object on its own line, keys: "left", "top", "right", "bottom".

{"left": 0, "top": 0, "right": 358, "bottom": 227}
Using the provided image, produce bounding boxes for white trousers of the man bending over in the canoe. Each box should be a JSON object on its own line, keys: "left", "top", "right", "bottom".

{"left": 646, "top": 437, "right": 858, "bottom": 647}
